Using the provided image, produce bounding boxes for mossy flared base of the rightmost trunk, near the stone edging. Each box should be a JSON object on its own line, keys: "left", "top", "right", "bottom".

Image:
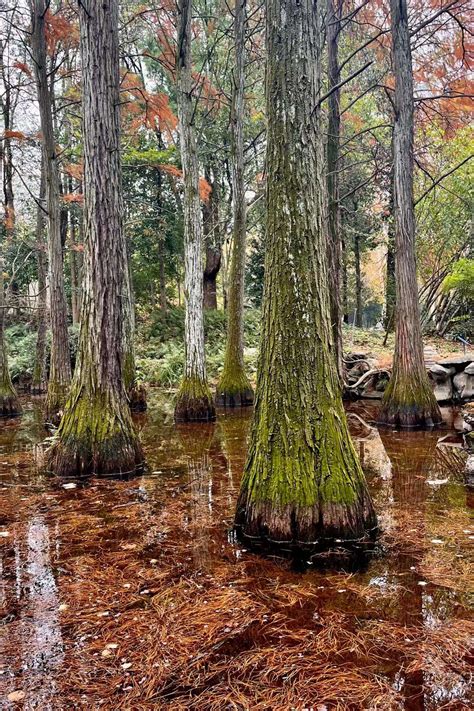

{"left": 377, "top": 378, "right": 443, "bottom": 428}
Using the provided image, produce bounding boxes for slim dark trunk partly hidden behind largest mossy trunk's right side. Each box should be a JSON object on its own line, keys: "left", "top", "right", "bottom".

{"left": 326, "top": 0, "right": 343, "bottom": 382}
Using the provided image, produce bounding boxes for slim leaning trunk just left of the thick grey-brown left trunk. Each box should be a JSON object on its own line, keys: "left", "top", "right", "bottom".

{"left": 31, "top": 0, "right": 71, "bottom": 422}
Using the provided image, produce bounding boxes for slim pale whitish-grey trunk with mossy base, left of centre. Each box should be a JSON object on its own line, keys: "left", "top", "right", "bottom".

{"left": 175, "top": 0, "right": 215, "bottom": 421}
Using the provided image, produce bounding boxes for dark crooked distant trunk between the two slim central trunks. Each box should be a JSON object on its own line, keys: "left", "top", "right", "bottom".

{"left": 202, "top": 170, "right": 222, "bottom": 310}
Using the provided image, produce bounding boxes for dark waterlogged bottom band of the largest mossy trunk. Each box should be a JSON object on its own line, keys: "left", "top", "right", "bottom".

{"left": 235, "top": 489, "right": 377, "bottom": 554}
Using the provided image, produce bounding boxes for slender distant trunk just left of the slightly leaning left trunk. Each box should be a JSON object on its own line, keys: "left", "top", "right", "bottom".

{"left": 31, "top": 163, "right": 48, "bottom": 395}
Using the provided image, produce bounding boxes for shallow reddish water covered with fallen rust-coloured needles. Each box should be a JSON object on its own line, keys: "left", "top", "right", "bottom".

{"left": 0, "top": 393, "right": 474, "bottom": 711}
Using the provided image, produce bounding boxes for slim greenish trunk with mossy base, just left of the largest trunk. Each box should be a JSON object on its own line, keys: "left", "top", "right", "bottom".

{"left": 217, "top": 0, "right": 253, "bottom": 407}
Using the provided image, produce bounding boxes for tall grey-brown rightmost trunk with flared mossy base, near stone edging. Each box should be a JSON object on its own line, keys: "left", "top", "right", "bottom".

{"left": 379, "top": 0, "right": 441, "bottom": 427}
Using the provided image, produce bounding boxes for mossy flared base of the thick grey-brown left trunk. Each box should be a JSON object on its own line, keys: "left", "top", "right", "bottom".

{"left": 45, "top": 392, "right": 144, "bottom": 476}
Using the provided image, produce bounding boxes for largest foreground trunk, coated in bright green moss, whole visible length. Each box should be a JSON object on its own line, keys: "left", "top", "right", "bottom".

{"left": 236, "top": 0, "right": 376, "bottom": 548}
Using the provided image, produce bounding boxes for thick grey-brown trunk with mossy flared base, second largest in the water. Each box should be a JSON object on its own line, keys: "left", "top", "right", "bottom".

{"left": 47, "top": 0, "right": 143, "bottom": 475}
